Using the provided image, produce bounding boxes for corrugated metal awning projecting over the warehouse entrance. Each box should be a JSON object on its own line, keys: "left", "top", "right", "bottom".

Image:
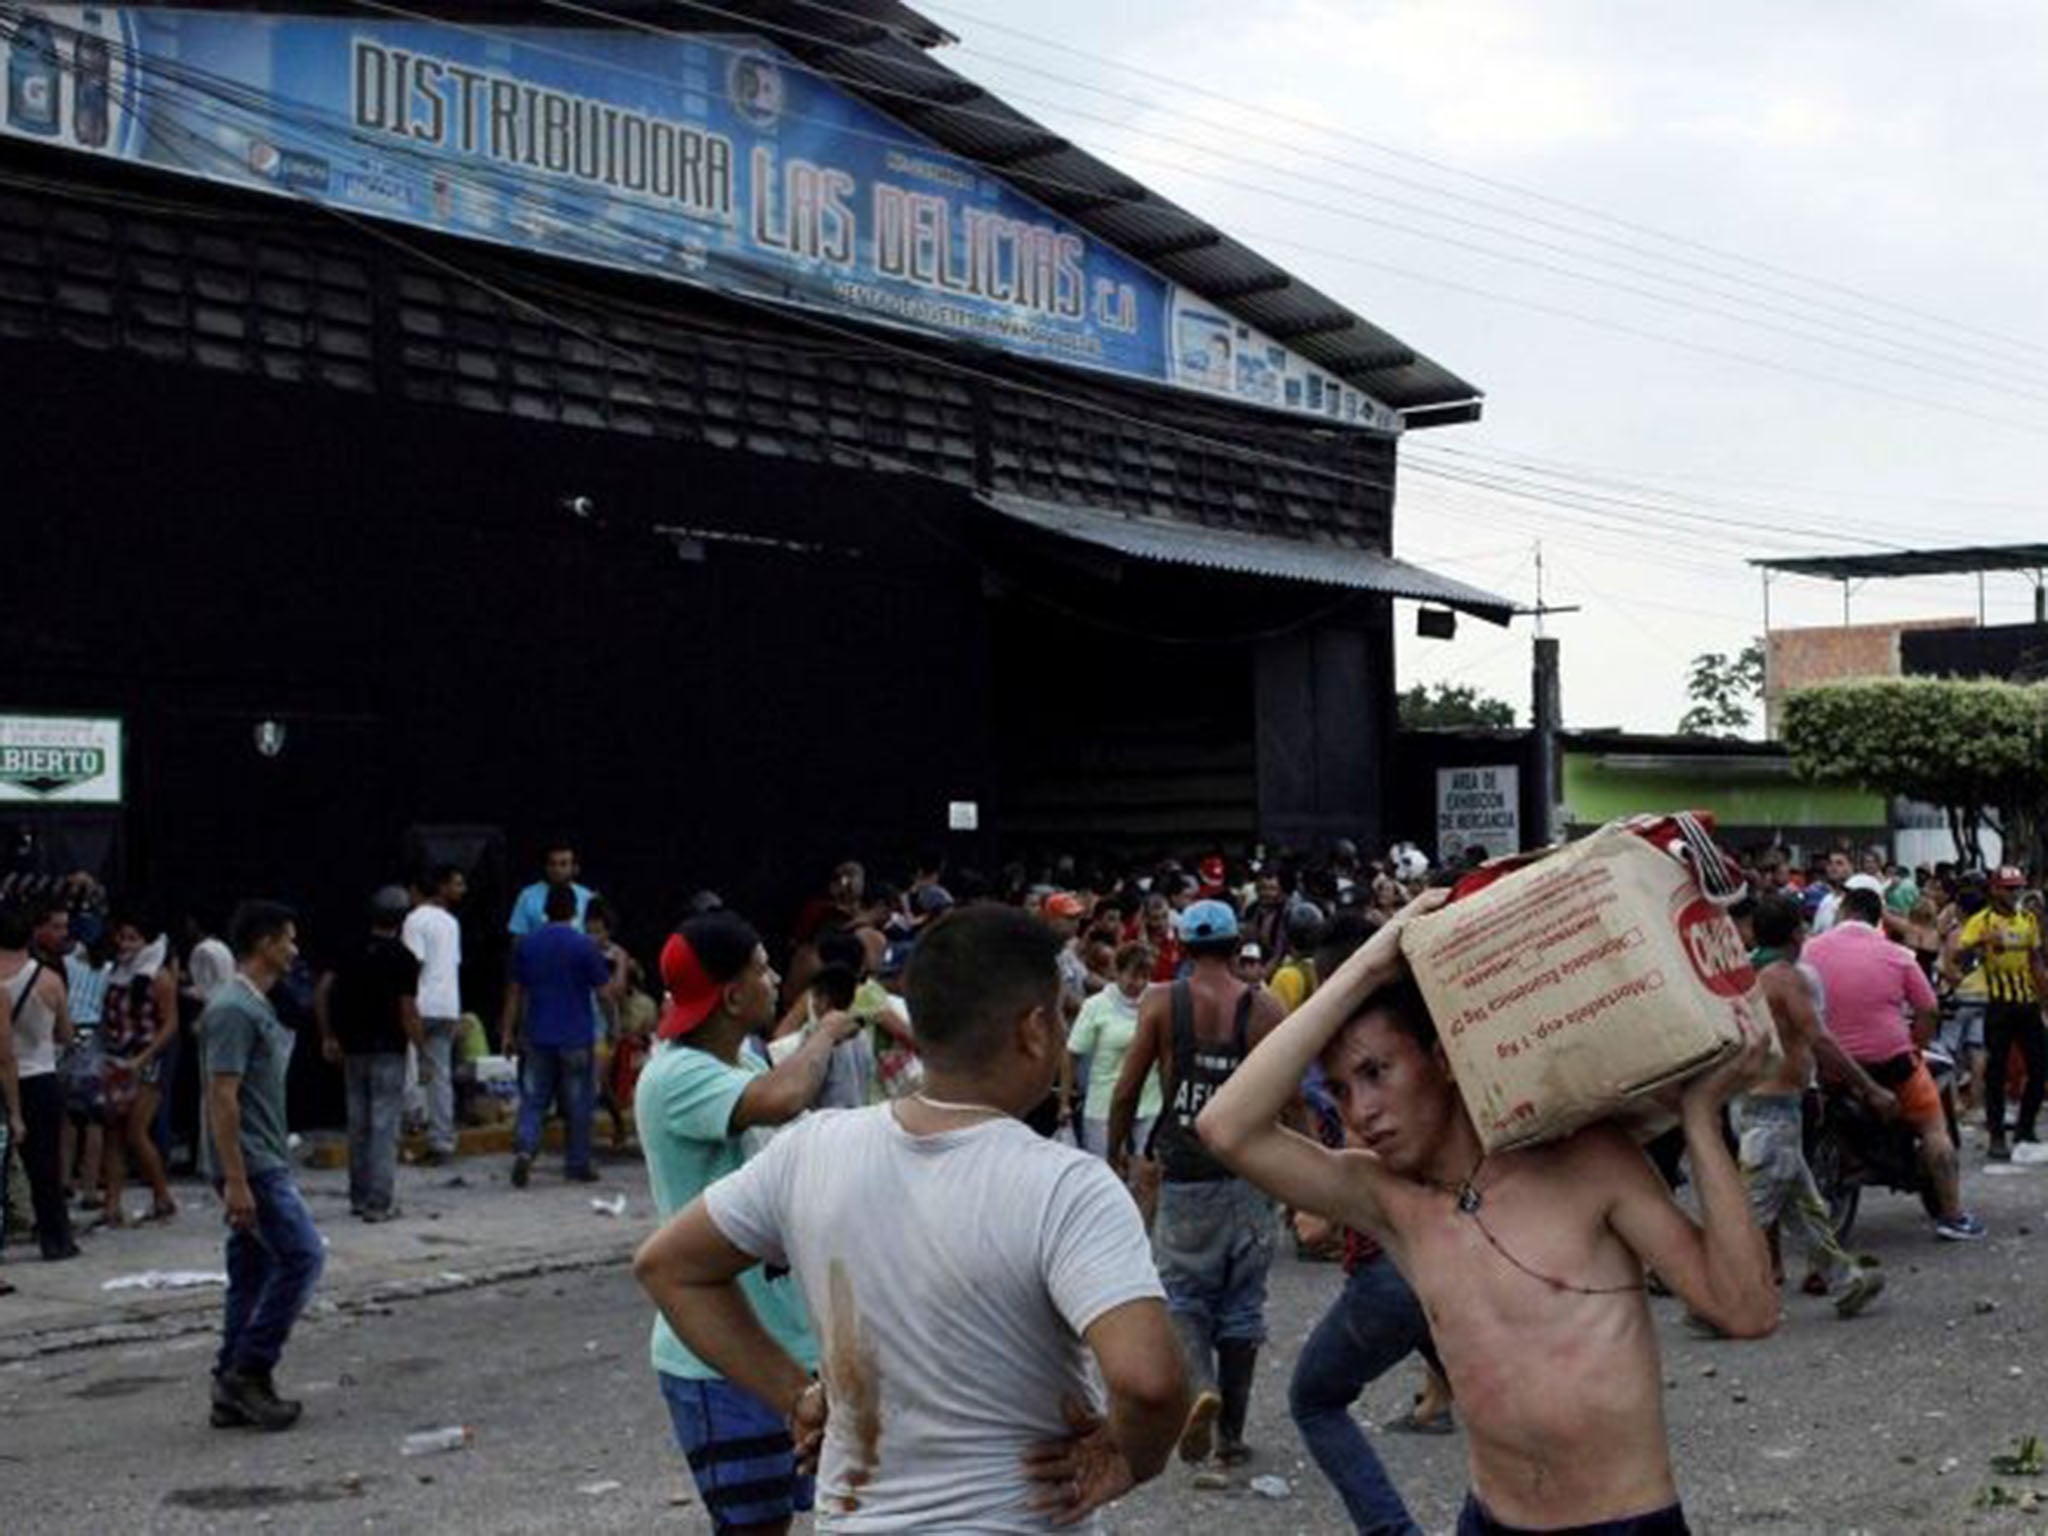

{"left": 975, "top": 492, "right": 1513, "bottom": 625}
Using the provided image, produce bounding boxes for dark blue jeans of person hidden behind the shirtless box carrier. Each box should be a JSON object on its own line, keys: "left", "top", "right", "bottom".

{"left": 1286, "top": 1260, "right": 1432, "bottom": 1536}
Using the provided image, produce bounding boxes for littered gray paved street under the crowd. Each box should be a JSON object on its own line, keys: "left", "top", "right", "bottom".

{"left": 12, "top": 1159, "right": 2048, "bottom": 1536}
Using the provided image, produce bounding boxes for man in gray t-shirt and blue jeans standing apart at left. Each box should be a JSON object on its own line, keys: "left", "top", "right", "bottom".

{"left": 197, "top": 901, "right": 324, "bottom": 1430}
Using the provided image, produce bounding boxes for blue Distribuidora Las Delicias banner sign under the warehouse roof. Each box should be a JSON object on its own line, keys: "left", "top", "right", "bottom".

{"left": 0, "top": 0, "right": 1399, "bottom": 430}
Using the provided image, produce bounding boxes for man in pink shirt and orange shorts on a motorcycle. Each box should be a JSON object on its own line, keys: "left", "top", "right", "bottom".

{"left": 1800, "top": 885, "right": 1985, "bottom": 1243}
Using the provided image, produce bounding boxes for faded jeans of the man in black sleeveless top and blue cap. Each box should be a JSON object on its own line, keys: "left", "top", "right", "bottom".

{"left": 1153, "top": 1180, "right": 1276, "bottom": 1391}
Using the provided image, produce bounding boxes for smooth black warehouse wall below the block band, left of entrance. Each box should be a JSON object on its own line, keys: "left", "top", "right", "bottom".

{"left": 0, "top": 346, "right": 989, "bottom": 978}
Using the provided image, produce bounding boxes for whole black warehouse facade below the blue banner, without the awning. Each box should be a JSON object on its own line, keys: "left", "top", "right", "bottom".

{"left": 0, "top": 145, "right": 1395, "bottom": 975}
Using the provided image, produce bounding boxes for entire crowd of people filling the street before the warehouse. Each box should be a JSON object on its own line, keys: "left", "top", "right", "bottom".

{"left": 0, "top": 842, "right": 2048, "bottom": 1532}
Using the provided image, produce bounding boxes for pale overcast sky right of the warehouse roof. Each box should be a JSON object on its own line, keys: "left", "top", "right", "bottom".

{"left": 922, "top": 0, "right": 2048, "bottom": 731}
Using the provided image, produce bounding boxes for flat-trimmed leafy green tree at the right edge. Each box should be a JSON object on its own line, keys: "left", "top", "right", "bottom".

{"left": 1784, "top": 678, "right": 2048, "bottom": 864}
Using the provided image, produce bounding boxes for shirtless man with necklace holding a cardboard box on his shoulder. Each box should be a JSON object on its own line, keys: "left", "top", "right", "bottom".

{"left": 1200, "top": 895, "right": 1778, "bottom": 1536}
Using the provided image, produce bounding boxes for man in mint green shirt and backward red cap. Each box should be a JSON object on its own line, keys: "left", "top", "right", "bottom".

{"left": 633, "top": 911, "right": 860, "bottom": 1536}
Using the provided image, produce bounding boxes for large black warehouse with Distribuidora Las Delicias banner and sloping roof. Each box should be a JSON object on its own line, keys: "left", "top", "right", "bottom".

{"left": 0, "top": 0, "right": 1507, "bottom": 962}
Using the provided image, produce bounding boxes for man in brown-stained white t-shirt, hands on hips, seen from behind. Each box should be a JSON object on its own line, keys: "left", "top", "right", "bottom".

{"left": 633, "top": 905, "right": 1188, "bottom": 1532}
